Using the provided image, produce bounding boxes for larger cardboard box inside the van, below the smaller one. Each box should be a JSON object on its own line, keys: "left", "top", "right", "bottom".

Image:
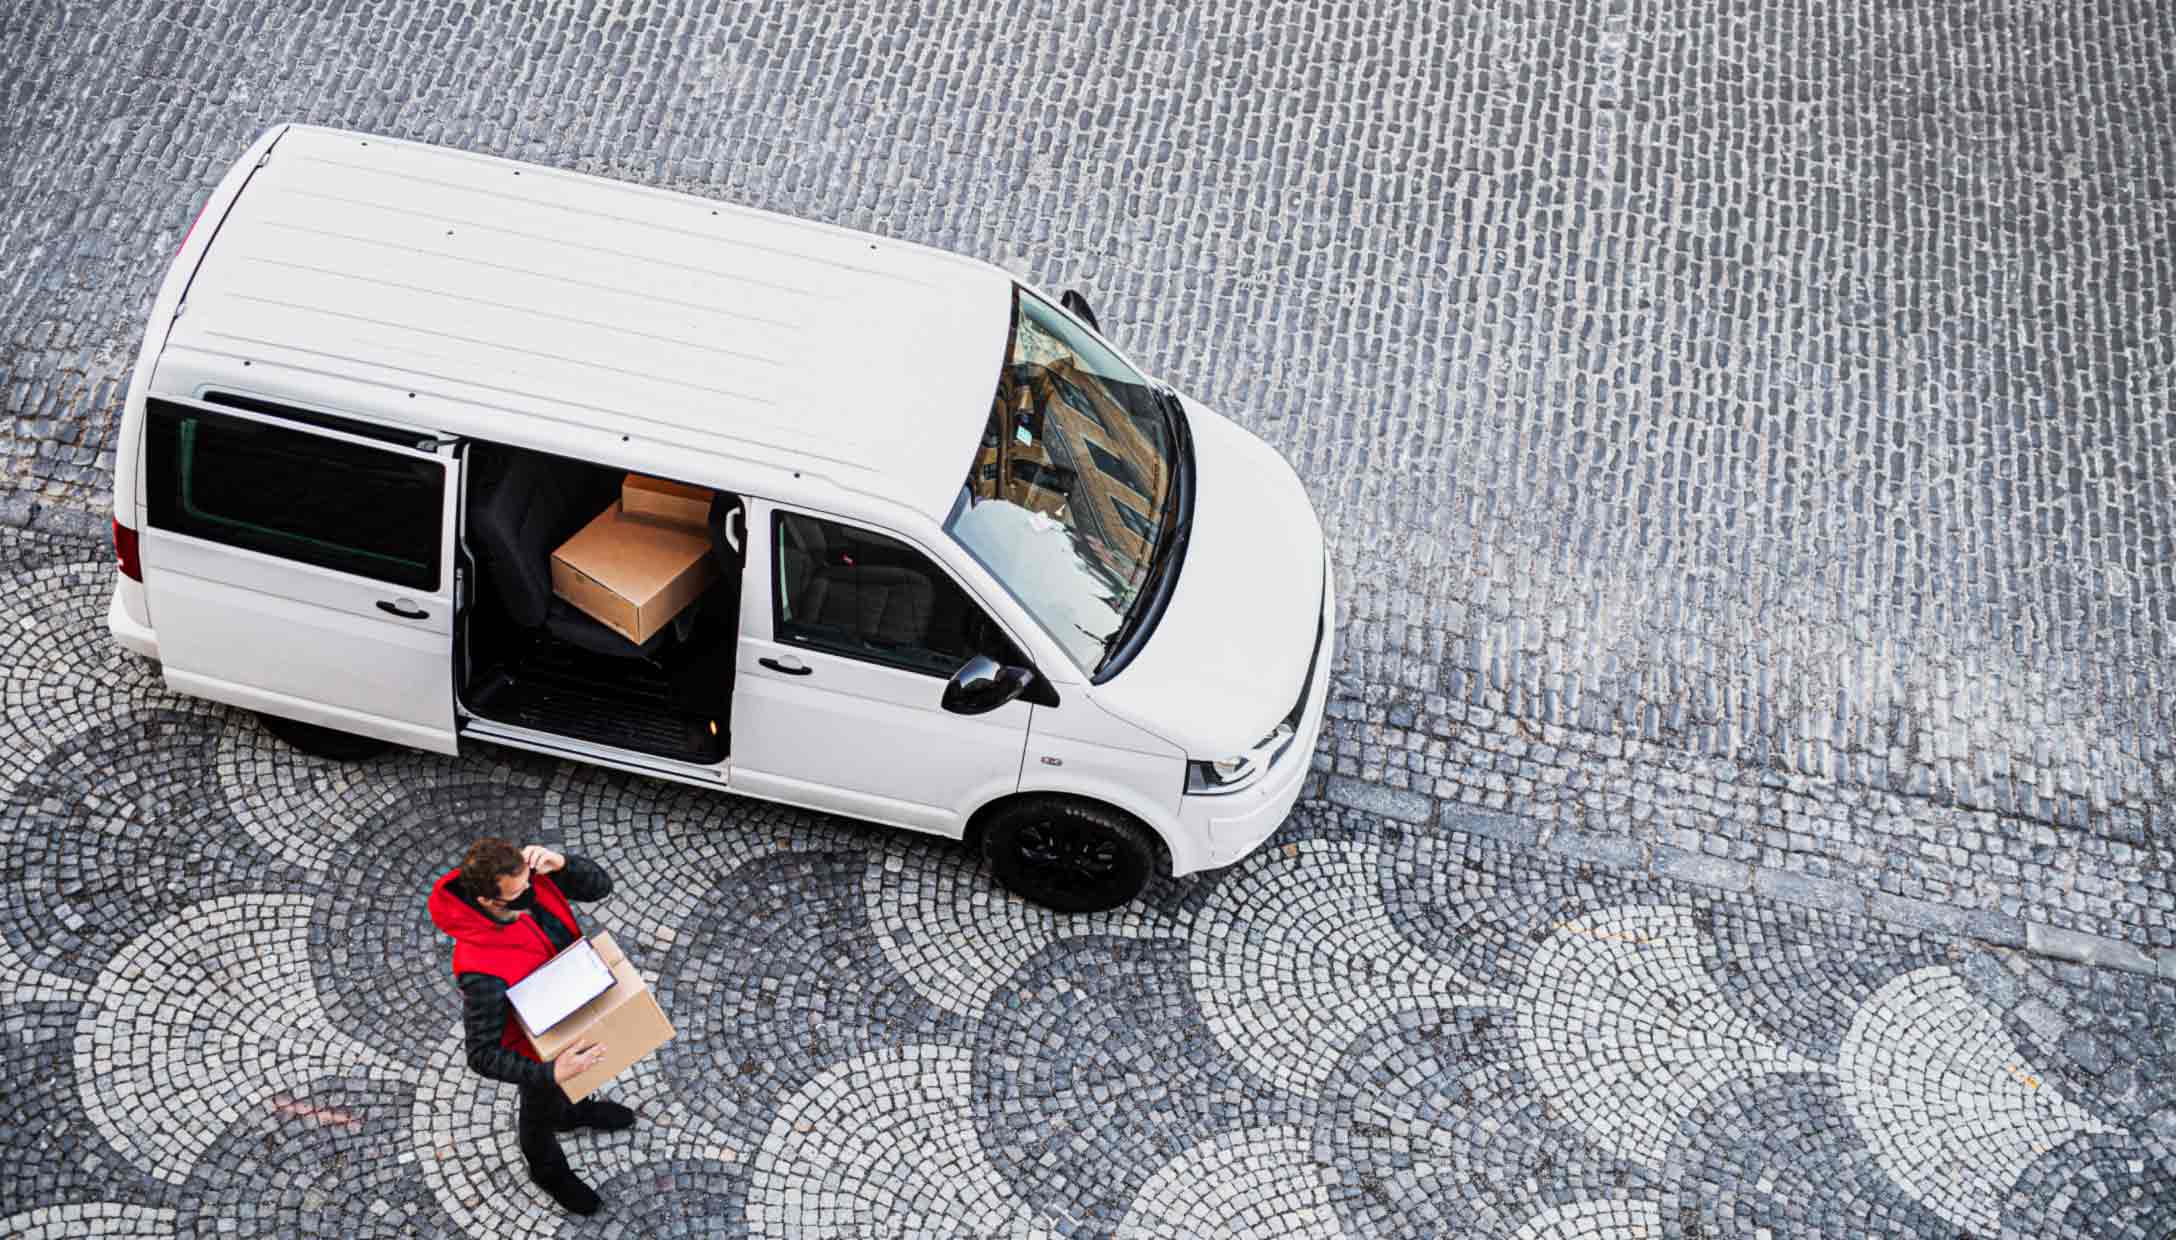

{"left": 551, "top": 505, "right": 718, "bottom": 646}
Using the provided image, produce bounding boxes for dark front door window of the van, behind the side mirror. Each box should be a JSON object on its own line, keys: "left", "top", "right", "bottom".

{"left": 770, "top": 513, "right": 1023, "bottom": 677}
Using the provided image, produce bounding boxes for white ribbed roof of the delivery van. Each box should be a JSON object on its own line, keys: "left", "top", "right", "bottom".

{"left": 168, "top": 126, "right": 1012, "bottom": 518}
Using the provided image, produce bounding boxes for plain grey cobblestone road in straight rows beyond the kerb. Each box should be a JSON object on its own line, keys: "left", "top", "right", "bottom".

{"left": 0, "top": 0, "right": 2176, "bottom": 968}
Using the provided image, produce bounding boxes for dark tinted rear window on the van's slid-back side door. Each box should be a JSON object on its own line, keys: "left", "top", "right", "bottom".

{"left": 146, "top": 400, "right": 446, "bottom": 590}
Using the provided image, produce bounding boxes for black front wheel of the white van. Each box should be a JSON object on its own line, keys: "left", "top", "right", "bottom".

{"left": 981, "top": 796, "right": 1155, "bottom": 914}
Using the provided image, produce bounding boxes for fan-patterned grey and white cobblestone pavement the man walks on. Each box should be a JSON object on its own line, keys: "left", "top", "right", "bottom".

{"left": 0, "top": 519, "right": 2176, "bottom": 1240}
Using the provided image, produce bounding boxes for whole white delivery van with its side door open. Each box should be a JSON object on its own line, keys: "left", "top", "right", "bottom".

{"left": 109, "top": 126, "right": 1334, "bottom": 909}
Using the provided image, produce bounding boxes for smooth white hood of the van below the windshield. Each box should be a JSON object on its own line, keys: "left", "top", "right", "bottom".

{"left": 1095, "top": 396, "right": 1325, "bottom": 759}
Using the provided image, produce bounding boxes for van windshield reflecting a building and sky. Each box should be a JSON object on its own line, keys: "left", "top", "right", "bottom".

{"left": 944, "top": 289, "right": 1177, "bottom": 672}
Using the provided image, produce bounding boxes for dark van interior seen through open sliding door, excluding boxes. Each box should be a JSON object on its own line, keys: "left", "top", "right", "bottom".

{"left": 459, "top": 442, "right": 746, "bottom": 766}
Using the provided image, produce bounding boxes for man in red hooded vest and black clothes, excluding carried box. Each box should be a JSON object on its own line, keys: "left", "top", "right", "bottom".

{"left": 429, "top": 838, "right": 635, "bottom": 1214}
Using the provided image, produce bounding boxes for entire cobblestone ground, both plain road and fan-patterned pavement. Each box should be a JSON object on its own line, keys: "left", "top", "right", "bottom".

{"left": 0, "top": 0, "right": 2176, "bottom": 1238}
